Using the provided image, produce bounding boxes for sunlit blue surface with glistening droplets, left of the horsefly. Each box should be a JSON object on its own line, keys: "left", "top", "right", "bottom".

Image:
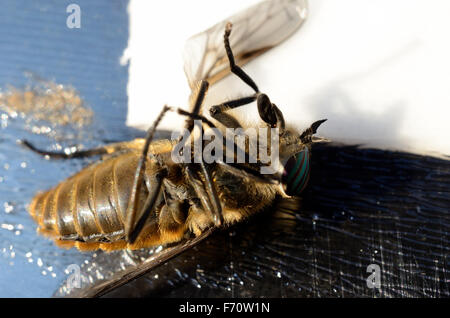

{"left": 0, "top": 0, "right": 132, "bottom": 297}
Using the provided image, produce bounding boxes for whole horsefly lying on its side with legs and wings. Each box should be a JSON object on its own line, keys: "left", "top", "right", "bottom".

{"left": 23, "top": 0, "right": 325, "bottom": 296}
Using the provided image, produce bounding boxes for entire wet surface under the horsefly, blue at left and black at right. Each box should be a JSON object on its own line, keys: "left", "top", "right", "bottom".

{"left": 0, "top": 0, "right": 450, "bottom": 297}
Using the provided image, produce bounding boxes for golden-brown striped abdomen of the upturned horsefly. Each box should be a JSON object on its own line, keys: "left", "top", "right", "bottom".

{"left": 30, "top": 152, "right": 154, "bottom": 250}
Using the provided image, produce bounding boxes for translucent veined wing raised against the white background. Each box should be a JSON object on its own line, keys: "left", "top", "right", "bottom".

{"left": 184, "top": 0, "right": 308, "bottom": 89}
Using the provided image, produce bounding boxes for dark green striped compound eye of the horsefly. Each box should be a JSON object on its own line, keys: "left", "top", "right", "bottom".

{"left": 282, "top": 147, "right": 311, "bottom": 196}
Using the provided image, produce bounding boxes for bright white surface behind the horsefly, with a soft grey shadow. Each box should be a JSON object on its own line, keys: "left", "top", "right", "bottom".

{"left": 122, "top": 0, "right": 450, "bottom": 155}
